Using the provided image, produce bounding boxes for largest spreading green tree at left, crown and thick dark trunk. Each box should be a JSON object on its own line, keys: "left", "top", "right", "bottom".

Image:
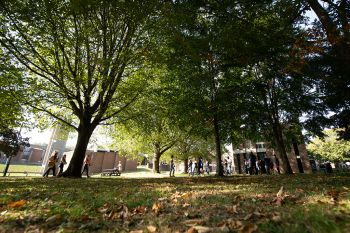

{"left": 0, "top": 0, "right": 157, "bottom": 177}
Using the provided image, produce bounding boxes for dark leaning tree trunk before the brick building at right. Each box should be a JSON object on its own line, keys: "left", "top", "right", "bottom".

{"left": 272, "top": 122, "right": 293, "bottom": 174}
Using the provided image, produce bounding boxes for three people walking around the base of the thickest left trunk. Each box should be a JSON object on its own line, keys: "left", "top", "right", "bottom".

{"left": 43, "top": 151, "right": 91, "bottom": 177}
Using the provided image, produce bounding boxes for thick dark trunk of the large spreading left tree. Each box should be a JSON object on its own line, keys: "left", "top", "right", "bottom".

{"left": 61, "top": 124, "right": 95, "bottom": 178}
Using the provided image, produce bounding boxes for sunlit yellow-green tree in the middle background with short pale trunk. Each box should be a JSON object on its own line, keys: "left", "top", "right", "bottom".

{"left": 110, "top": 73, "right": 179, "bottom": 173}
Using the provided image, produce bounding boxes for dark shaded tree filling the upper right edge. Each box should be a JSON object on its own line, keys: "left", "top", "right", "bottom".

{"left": 306, "top": 0, "right": 350, "bottom": 140}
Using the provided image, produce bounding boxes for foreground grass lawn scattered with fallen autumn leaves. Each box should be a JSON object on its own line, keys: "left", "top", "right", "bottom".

{"left": 0, "top": 173, "right": 350, "bottom": 233}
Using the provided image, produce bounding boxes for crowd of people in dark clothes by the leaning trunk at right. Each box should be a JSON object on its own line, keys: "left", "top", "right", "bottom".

{"left": 244, "top": 153, "right": 281, "bottom": 175}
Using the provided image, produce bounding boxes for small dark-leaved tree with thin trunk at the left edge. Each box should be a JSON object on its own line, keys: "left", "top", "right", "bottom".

{"left": 0, "top": 128, "right": 30, "bottom": 176}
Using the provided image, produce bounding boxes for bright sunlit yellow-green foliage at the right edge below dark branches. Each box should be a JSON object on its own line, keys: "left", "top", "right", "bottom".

{"left": 307, "top": 129, "right": 350, "bottom": 162}
